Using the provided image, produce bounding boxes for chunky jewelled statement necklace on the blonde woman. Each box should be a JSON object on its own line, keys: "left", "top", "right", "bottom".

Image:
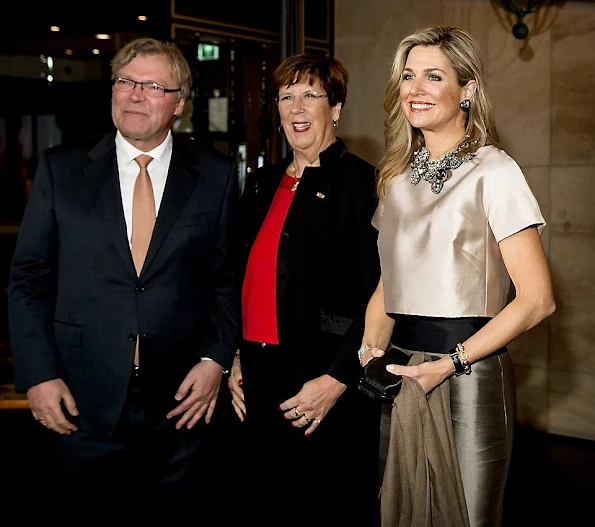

{"left": 409, "top": 139, "right": 479, "bottom": 194}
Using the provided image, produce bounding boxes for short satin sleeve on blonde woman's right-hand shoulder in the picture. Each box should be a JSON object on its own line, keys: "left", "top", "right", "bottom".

{"left": 484, "top": 151, "right": 546, "bottom": 242}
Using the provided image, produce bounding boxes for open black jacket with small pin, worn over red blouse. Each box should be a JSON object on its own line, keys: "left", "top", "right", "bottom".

{"left": 239, "top": 139, "right": 380, "bottom": 385}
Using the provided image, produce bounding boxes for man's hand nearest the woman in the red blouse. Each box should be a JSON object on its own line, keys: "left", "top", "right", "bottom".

{"left": 166, "top": 360, "right": 223, "bottom": 430}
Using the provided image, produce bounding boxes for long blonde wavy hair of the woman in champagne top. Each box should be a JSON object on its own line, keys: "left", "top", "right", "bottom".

{"left": 376, "top": 26, "right": 499, "bottom": 198}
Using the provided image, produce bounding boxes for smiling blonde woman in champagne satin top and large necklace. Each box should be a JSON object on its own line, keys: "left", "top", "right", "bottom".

{"left": 360, "top": 27, "right": 555, "bottom": 527}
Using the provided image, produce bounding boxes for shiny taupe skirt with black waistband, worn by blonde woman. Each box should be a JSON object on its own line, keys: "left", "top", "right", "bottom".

{"left": 383, "top": 315, "right": 516, "bottom": 527}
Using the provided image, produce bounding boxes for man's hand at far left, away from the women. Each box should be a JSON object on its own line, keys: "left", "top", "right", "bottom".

{"left": 27, "top": 379, "right": 79, "bottom": 435}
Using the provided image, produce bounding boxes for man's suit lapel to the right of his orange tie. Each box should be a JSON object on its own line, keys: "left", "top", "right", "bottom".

{"left": 141, "top": 139, "right": 198, "bottom": 275}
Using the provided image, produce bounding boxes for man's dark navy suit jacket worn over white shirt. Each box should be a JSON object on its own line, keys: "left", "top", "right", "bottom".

{"left": 9, "top": 134, "right": 238, "bottom": 434}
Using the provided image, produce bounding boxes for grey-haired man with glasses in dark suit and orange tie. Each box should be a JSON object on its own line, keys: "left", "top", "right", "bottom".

{"left": 9, "top": 38, "right": 238, "bottom": 506}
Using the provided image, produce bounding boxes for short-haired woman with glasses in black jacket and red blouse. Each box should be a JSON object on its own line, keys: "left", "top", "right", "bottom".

{"left": 229, "top": 54, "right": 380, "bottom": 526}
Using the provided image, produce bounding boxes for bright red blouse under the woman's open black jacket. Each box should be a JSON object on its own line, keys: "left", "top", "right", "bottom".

{"left": 242, "top": 174, "right": 295, "bottom": 344}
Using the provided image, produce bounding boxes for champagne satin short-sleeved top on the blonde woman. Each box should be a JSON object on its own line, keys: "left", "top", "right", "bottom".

{"left": 372, "top": 146, "right": 545, "bottom": 317}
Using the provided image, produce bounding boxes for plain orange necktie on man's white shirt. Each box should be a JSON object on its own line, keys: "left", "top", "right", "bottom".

{"left": 131, "top": 154, "right": 156, "bottom": 365}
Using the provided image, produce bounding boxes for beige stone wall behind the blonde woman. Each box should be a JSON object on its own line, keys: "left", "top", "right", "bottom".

{"left": 335, "top": 0, "right": 595, "bottom": 439}
